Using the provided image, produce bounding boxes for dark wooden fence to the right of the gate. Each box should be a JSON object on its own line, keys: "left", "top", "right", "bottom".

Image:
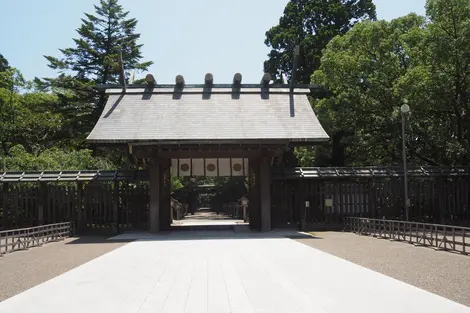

{"left": 272, "top": 177, "right": 470, "bottom": 227}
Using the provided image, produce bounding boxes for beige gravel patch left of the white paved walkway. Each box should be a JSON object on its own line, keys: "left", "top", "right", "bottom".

{"left": 0, "top": 237, "right": 129, "bottom": 301}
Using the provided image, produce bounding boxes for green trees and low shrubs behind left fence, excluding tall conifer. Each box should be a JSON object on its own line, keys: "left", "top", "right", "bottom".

{"left": 0, "top": 63, "right": 116, "bottom": 170}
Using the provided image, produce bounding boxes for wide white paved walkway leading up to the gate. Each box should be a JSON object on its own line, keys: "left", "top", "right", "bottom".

{"left": 0, "top": 232, "right": 470, "bottom": 313}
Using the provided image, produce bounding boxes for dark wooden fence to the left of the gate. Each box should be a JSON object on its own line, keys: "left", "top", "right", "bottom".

{"left": 0, "top": 182, "right": 149, "bottom": 231}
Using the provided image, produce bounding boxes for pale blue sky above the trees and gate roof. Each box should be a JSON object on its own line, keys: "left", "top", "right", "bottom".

{"left": 0, "top": 0, "right": 425, "bottom": 83}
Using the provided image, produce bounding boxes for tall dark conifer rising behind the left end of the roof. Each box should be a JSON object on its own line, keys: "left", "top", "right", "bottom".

{"left": 42, "top": 0, "right": 153, "bottom": 138}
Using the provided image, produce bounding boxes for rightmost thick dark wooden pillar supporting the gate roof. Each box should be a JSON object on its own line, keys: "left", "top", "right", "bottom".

{"left": 260, "top": 158, "right": 271, "bottom": 231}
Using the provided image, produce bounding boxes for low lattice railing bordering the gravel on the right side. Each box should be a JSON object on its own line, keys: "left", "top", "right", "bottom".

{"left": 343, "top": 217, "right": 470, "bottom": 255}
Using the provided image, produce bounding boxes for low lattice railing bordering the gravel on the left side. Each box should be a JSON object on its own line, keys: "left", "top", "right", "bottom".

{"left": 0, "top": 222, "right": 72, "bottom": 256}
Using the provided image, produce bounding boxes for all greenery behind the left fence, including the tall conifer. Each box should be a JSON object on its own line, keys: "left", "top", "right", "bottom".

{"left": 0, "top": 0, "right": 155, "bottom": 171}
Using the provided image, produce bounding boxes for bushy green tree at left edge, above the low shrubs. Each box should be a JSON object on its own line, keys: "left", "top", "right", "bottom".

{"left": 0, "top": 68, "right": 96, "bottom": 155}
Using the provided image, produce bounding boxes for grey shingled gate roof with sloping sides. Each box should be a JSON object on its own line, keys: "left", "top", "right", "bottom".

{"left": 87, "top": 80, "right": 329, "bottom": 144}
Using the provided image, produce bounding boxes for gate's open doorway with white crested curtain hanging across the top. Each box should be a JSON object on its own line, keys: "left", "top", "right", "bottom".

{"left": 171, "top": 159, "right": 249, "bottom": 229}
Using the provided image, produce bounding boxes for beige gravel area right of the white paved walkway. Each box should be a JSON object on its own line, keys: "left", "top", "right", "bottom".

{"left": 297, "top": 232, "right": 470, "bottom": 306}
